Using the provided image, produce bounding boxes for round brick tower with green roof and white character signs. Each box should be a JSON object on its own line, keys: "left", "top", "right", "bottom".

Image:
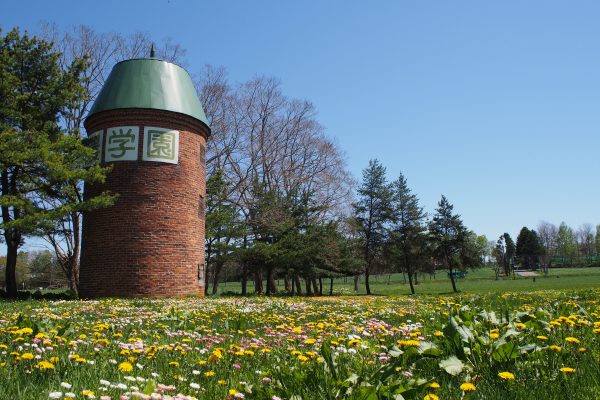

{"left": 79, "top": 57, "right": 210, "bottom": 298}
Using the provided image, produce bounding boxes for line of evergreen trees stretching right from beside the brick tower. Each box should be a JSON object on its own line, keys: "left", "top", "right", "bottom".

{"left": 207, "top": 160, "right": 489, "bottom": 295}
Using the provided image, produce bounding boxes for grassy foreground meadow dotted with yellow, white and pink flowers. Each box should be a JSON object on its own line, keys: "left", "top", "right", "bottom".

{"left": 0, "top": 290, "right": 600, "bottom": 400}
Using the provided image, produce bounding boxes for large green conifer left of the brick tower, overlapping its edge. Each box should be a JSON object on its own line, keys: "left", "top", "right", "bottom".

{"left": 0, "top": 29, "right": 112, "bottom": 297}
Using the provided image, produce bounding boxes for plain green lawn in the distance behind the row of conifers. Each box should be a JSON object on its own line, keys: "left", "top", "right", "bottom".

{"left": 219, "top": 267, "right": 600, "bottom": 295}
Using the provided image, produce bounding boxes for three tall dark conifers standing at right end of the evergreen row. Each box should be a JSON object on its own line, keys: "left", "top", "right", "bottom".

{"left": 350, "top": 160, "right": 487, "bottom": 294}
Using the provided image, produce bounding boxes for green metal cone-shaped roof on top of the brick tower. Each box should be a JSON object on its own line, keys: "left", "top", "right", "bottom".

{"left": 88, "top": 58, "right": 208, "bottom": 126}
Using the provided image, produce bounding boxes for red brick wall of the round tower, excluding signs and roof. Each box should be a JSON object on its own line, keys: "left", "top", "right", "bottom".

{"left": 80, "top": 109, "right": 209, "bottom": 298}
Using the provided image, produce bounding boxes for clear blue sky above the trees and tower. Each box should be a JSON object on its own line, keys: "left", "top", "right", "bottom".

{"left": 0, "top": 0, "right": 600, "bottom": 239}
